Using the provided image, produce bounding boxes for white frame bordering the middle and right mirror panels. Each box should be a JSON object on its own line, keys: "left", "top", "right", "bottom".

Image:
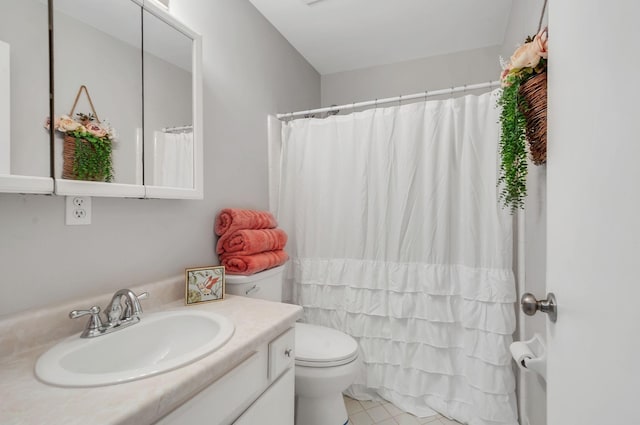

{"left": 51, "top": 0, "right": 204, "bottom": 199}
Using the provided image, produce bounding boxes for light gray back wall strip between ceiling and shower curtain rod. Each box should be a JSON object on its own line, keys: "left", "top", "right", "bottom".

{"left": 322, "top": 46, "right": 500, "bottom": 106}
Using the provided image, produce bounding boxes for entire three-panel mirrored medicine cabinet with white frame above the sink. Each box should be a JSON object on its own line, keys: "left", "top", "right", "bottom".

{"left": 0, "top": 0, "right": 203, "bottom": 199}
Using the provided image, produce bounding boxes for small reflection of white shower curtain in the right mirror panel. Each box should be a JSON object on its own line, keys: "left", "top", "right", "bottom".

{"left": 153, "top": 131, "right": 193, "bottom": 188}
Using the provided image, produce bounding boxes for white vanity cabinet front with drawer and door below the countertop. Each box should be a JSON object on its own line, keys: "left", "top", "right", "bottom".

{"left": 156, "top": 328, "right": 295, "bottom": 425}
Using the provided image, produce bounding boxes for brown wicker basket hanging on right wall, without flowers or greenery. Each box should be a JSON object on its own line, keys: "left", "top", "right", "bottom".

{"left": 519, "top": 72, "right": 547, "bottom": 165}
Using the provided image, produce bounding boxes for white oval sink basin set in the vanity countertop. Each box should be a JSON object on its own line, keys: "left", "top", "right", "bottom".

{"left": 35, "top": 309, "right": 235, "bottom": 387}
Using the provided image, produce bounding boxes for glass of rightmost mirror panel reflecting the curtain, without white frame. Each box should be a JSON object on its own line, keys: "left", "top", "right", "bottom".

{"left": 143, "top": 11, "right": 194, "bottom": 189}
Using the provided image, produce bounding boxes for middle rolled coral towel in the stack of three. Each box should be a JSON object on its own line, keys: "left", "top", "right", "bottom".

{"left": 216, "top": 229, "right": 287, "bottom": 255}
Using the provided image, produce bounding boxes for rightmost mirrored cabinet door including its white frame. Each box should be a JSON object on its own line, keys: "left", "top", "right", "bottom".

{"left": 142, "top": 2, "right": 203, "bottom": 199}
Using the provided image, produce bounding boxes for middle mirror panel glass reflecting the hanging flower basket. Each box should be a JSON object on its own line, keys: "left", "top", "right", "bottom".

{"left": 53, "top": 0, "right": 142, "bottom": 184}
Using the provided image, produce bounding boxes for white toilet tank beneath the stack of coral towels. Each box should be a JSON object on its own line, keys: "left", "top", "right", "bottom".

{"left": 225, "top": 265, "right": 285, "bottom": 302}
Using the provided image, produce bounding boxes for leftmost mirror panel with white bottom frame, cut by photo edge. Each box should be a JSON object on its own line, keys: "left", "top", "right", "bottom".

{"left": 0, "top": 0, "right": 53, "bottom": 193}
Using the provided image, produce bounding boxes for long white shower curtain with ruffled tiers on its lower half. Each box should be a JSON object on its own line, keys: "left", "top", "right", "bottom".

{"left": 270, "top": 92, "right": 517, "bottom": 425}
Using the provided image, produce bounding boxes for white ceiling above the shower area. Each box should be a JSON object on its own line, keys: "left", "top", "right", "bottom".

{"left": 249, "top": 0, "right": 513, "bottom": 75}
